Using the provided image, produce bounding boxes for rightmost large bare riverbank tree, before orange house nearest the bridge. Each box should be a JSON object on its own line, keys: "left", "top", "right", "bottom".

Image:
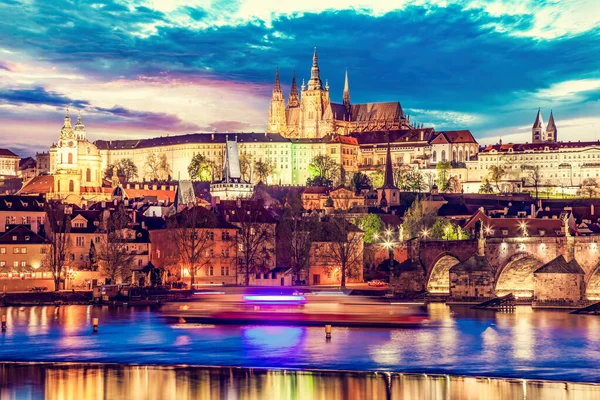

{"left": 321, "top": 210, "right": 364, "bottom": 288}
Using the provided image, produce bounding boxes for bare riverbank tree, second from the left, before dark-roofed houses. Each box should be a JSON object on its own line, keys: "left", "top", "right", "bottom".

{"left": 94, "top": 207, "right": 135, "bottom": 283}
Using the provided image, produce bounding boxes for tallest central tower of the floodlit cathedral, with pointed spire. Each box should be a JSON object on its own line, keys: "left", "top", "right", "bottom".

{"left": 300, "top": 47, "right": 329, "bottom": 138}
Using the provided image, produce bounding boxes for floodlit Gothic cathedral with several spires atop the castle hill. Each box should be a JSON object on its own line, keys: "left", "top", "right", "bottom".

{"left": 268, "top": 48, "right": 412, "bottom": 139}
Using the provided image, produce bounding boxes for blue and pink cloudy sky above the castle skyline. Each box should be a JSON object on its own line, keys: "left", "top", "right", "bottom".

{"left": 0, "top": 0, "right": 600, "bottom": 156}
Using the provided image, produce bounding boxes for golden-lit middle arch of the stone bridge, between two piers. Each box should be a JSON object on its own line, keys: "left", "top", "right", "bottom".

{"left": 496, "top": 253, "right": 544, "bottom": 297}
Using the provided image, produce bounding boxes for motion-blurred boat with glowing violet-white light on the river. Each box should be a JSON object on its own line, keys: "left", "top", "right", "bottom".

{"left": 161, "top": 291, "right": 429, "bottom": 327}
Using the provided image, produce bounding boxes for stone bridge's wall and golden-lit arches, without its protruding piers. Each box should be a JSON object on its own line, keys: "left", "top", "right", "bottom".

{"left": 406, "top": 236, "right": 600, "bottom": 300}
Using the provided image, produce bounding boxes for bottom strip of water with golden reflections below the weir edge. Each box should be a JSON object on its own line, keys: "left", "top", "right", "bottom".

{"left": 0, "top": 364, "right": 600, "bottom": 400}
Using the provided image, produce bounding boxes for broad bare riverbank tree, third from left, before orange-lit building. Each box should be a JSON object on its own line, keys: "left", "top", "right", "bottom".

{"left": 167, "top": 206, "right": 221, "bottom": 287}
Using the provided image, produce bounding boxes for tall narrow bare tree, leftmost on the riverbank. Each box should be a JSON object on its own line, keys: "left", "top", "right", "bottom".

{"left": 44, "top": 201, "right": 73, "bottom": 291}
